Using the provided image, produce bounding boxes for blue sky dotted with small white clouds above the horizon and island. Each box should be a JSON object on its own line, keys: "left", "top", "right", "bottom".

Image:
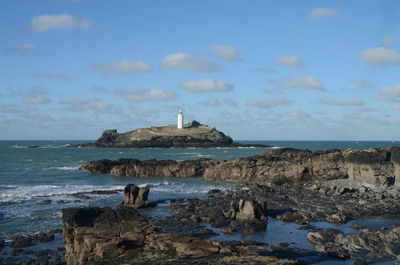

{"left": 0, "top": 0, "right": 400, "bottom": 141}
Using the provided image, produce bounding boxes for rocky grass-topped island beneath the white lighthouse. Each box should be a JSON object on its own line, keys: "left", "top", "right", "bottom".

{"left": 71, "top": 121, "right": 269, "bottom": 148}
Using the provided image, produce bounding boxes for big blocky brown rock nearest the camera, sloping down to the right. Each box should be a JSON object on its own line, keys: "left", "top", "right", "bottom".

{"left": 63, "top": 206, "right": 300, "bottom": 265}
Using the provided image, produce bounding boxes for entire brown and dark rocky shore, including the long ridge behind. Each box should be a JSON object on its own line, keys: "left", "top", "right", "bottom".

{"left": 0, "top": 147, "right": 400, "bottom": 265}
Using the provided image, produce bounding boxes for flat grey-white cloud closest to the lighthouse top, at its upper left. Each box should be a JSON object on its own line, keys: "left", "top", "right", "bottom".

{"left": 115, "top": 88, "right": 177, "bottom": 102}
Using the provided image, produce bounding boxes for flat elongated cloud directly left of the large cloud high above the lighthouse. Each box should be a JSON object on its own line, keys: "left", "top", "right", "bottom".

{"left": 90, "top": 60, "right": 152, "bottom": 75}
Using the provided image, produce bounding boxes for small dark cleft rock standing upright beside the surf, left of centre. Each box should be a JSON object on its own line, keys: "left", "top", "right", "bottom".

{"left": 122, "top": 184, "right": 150, "bottom": 209}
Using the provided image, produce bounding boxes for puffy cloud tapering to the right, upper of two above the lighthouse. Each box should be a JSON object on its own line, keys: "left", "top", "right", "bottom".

{"left": 161, "top": 53, "right": 222, "bottom": 72}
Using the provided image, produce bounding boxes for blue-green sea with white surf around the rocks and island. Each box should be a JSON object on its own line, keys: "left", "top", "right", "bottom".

{"left": 0, "top": 140, "right": 400, "bottom": 262}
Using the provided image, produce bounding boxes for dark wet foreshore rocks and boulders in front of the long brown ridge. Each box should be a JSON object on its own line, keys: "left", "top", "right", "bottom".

{"left": 2, "top": 180, "right": 400, "bottom": 265}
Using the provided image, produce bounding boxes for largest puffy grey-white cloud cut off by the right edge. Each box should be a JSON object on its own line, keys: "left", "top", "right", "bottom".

{"left": 361, "top": 47, "right": 400, "bottom": 67}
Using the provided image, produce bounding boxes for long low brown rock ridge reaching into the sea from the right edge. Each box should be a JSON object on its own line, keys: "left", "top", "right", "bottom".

{"left": 80, "top": 147, "right": 400, "bottom": 187}
